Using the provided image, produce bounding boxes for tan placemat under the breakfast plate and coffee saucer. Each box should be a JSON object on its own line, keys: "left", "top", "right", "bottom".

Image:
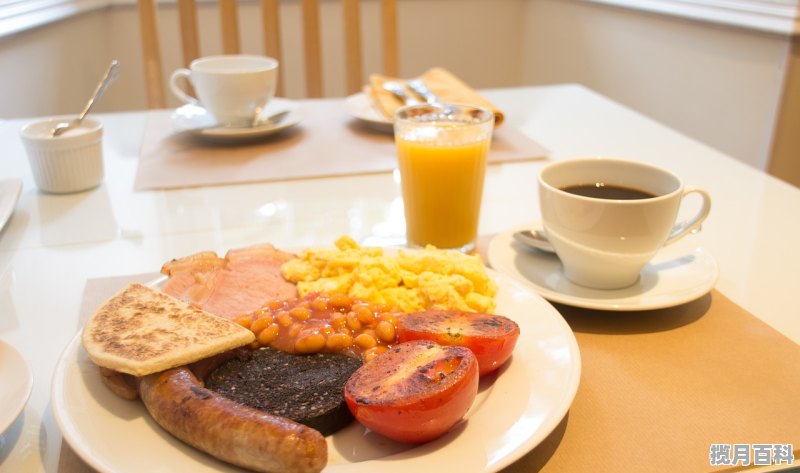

{"left": 59, "top": 264, "right": 800, "bottom": 473}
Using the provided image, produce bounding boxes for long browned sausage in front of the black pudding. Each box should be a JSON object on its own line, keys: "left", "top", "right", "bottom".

{"left": 139, "top": 366, "right": 328, "bottom": 473}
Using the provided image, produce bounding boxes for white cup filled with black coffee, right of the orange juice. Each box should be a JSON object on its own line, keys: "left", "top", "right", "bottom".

{"left": 539, "top": 157, "right": 711, "bottom": 289}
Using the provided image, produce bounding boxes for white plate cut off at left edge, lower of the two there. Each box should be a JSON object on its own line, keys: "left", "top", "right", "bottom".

{"left": 0, "top": 340, "right": 33, "bottom": 434}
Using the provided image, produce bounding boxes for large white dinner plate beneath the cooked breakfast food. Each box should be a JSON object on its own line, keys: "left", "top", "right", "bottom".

{"left": 51, "top": 271, "right": 581, "bottom": 473}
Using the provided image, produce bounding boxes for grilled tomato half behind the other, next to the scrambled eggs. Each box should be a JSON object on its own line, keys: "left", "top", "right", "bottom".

{"left": 397, "top": 310, "right": 519, "bottom": 376}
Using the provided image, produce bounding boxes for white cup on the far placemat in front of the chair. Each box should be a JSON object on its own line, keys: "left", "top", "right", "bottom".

{"left": 170, "top": 54, "right": 278, "bottom": 128}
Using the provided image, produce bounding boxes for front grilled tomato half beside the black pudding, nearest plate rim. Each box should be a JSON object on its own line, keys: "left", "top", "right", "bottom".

{"left": 344, "top": 340, "right": 478, "bottom": 443}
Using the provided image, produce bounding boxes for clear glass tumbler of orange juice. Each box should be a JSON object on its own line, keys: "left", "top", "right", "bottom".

{"left": 394, "top": 103, "right": 494, "bottom": 252}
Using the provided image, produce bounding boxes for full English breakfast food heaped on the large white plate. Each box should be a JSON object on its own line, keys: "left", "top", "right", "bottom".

{"left": 82, "top": 237, "right": 519, "bottom": 472}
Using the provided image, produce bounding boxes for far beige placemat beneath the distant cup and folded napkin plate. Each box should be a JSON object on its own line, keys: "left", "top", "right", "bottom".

{"left": 134, "top": 99, "right": 548, "bottom": 190}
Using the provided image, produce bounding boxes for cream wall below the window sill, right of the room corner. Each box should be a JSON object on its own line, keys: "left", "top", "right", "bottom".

{"left": 523, "top": 0, "right": 790, "bottom": 169}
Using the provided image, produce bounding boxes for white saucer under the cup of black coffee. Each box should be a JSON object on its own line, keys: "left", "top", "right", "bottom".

{"left": 488, "top": 225, "right": 719, "bottom": 311}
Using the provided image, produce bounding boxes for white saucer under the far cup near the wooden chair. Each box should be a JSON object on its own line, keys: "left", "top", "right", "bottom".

{"left": 172, "top": 98, "right": 303, "bottom": 142}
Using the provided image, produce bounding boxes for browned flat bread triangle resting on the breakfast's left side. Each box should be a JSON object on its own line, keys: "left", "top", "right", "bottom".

{"left": 82, "top": 284, "right": 255, "bottom": 376}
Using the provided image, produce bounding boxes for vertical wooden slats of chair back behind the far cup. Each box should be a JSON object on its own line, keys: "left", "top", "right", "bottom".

{"left": 138, "top": 0, "right": 398, "bottom": 108}
